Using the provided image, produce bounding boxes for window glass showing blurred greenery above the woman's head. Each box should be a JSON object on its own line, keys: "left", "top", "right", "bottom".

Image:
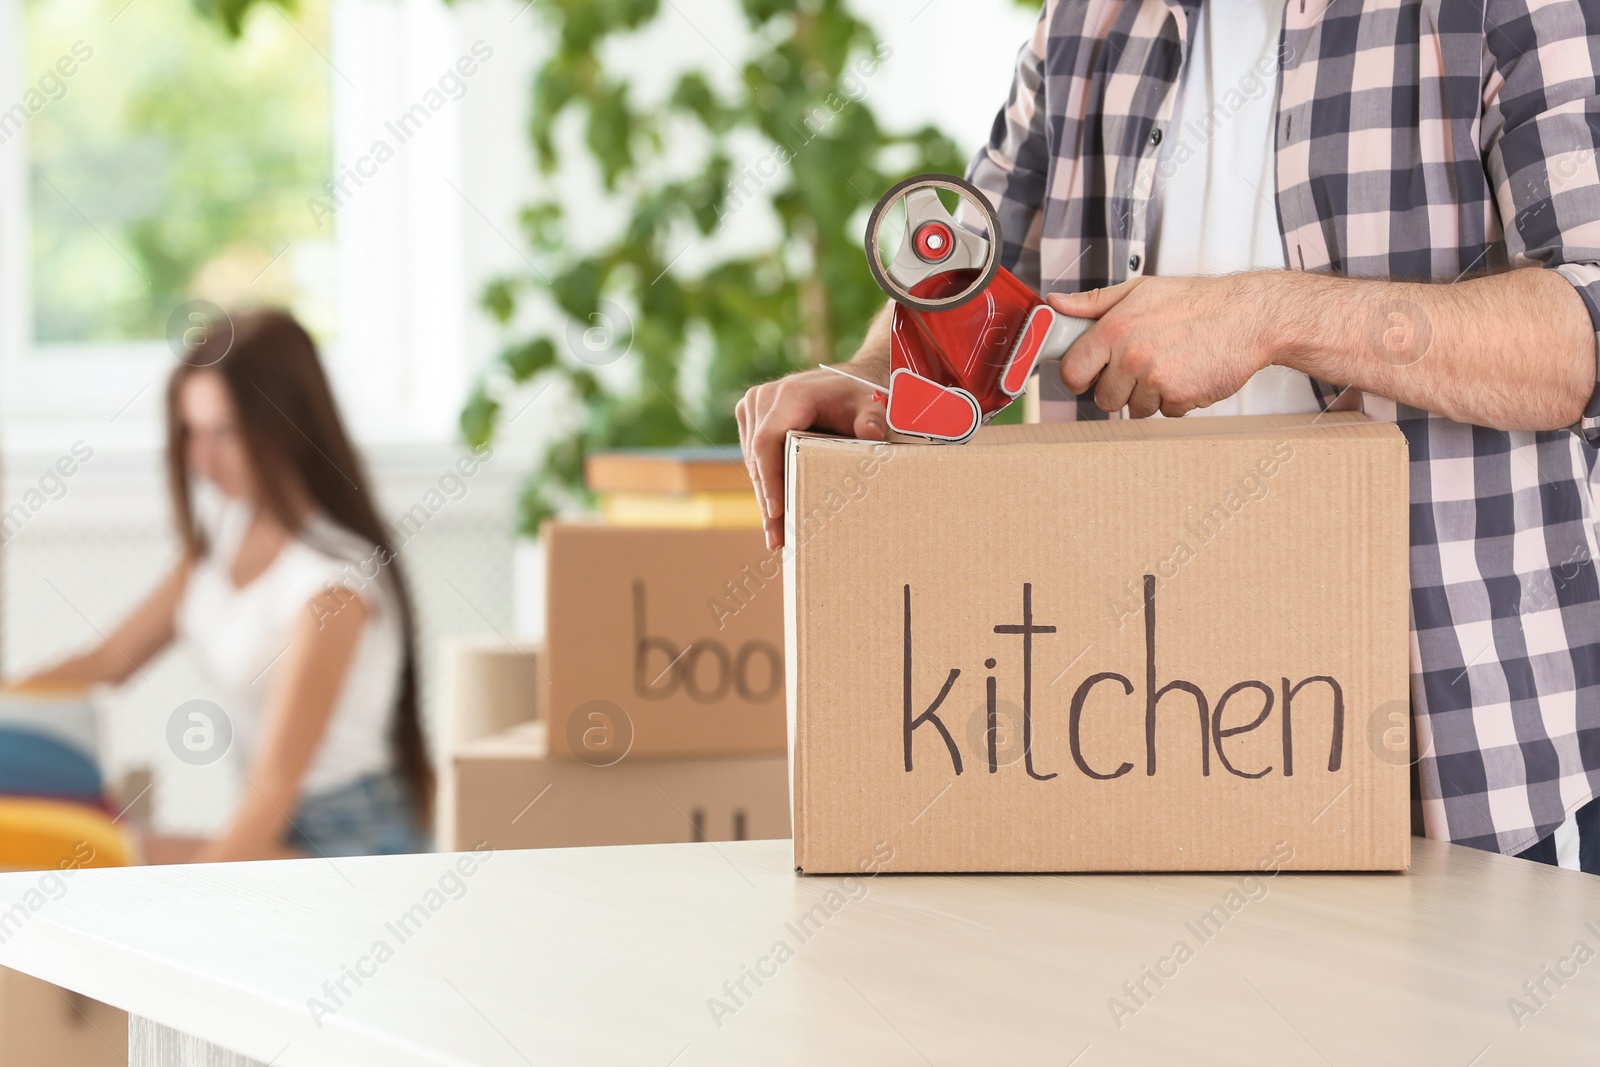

{"left": 21, "top": 0, "right": 336, "bottom": 348}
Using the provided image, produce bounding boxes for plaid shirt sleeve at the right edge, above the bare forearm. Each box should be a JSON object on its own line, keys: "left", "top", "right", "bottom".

{"left": 1483, "top": 0, "right": 1600, "bottom": 443}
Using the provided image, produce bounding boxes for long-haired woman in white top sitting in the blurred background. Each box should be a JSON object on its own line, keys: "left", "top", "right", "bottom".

{"left": 34, "top": 310, "right": 434, "bottom": 861}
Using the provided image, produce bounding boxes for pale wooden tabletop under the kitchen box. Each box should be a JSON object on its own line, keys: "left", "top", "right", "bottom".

{"left": 0, "top": 841, "right": 1600, "bottom": 1067}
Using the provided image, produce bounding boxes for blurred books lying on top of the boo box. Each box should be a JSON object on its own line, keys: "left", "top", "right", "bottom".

{"left": 584, "top": 445, "right": 762, "bottom": 530}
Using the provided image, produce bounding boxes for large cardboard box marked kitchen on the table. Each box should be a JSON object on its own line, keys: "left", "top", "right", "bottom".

{"left": 786, "top": 414, "right": 1410, "bottom": 873}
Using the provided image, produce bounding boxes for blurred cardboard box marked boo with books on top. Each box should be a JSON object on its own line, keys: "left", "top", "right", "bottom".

{"left": 544, "top": 523, "right": 786, "bottom": 763}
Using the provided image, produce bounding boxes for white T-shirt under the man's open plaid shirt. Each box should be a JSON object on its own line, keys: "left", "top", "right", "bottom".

{"left": 1149, "top": 0, "right": 1318, "bottom": 414}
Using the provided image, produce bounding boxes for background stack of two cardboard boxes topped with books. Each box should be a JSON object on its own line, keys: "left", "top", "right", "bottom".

{"left": 450, "top": 450, "right": 789, "bottom": 848}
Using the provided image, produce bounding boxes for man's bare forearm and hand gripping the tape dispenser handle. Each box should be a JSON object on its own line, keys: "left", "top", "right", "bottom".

{"left": 1050, "top": 267, "right": 1595, "bottom": 430}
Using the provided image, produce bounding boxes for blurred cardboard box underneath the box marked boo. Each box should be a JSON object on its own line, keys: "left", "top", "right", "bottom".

{"left": 446, "top": 723, "right": 789, "bottom": 849}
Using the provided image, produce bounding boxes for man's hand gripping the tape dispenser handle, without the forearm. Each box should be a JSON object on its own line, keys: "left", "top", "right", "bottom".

{"left": 1048, "top": 274, "right": 1272, "bottom": 419}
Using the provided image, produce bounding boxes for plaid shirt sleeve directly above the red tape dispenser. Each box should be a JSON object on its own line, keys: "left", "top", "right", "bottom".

{"left": 962, "top": 0, "right": 1058, "bottom": 293}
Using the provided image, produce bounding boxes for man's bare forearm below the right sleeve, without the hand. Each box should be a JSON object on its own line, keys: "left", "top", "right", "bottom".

{"left": 1262, "top": 269, "right": 1595, "bottom": 430}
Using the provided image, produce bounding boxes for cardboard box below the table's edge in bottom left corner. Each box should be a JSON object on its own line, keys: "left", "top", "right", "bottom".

{"left": 0, "top": 968, "right": 128, "bottom": 1067}
